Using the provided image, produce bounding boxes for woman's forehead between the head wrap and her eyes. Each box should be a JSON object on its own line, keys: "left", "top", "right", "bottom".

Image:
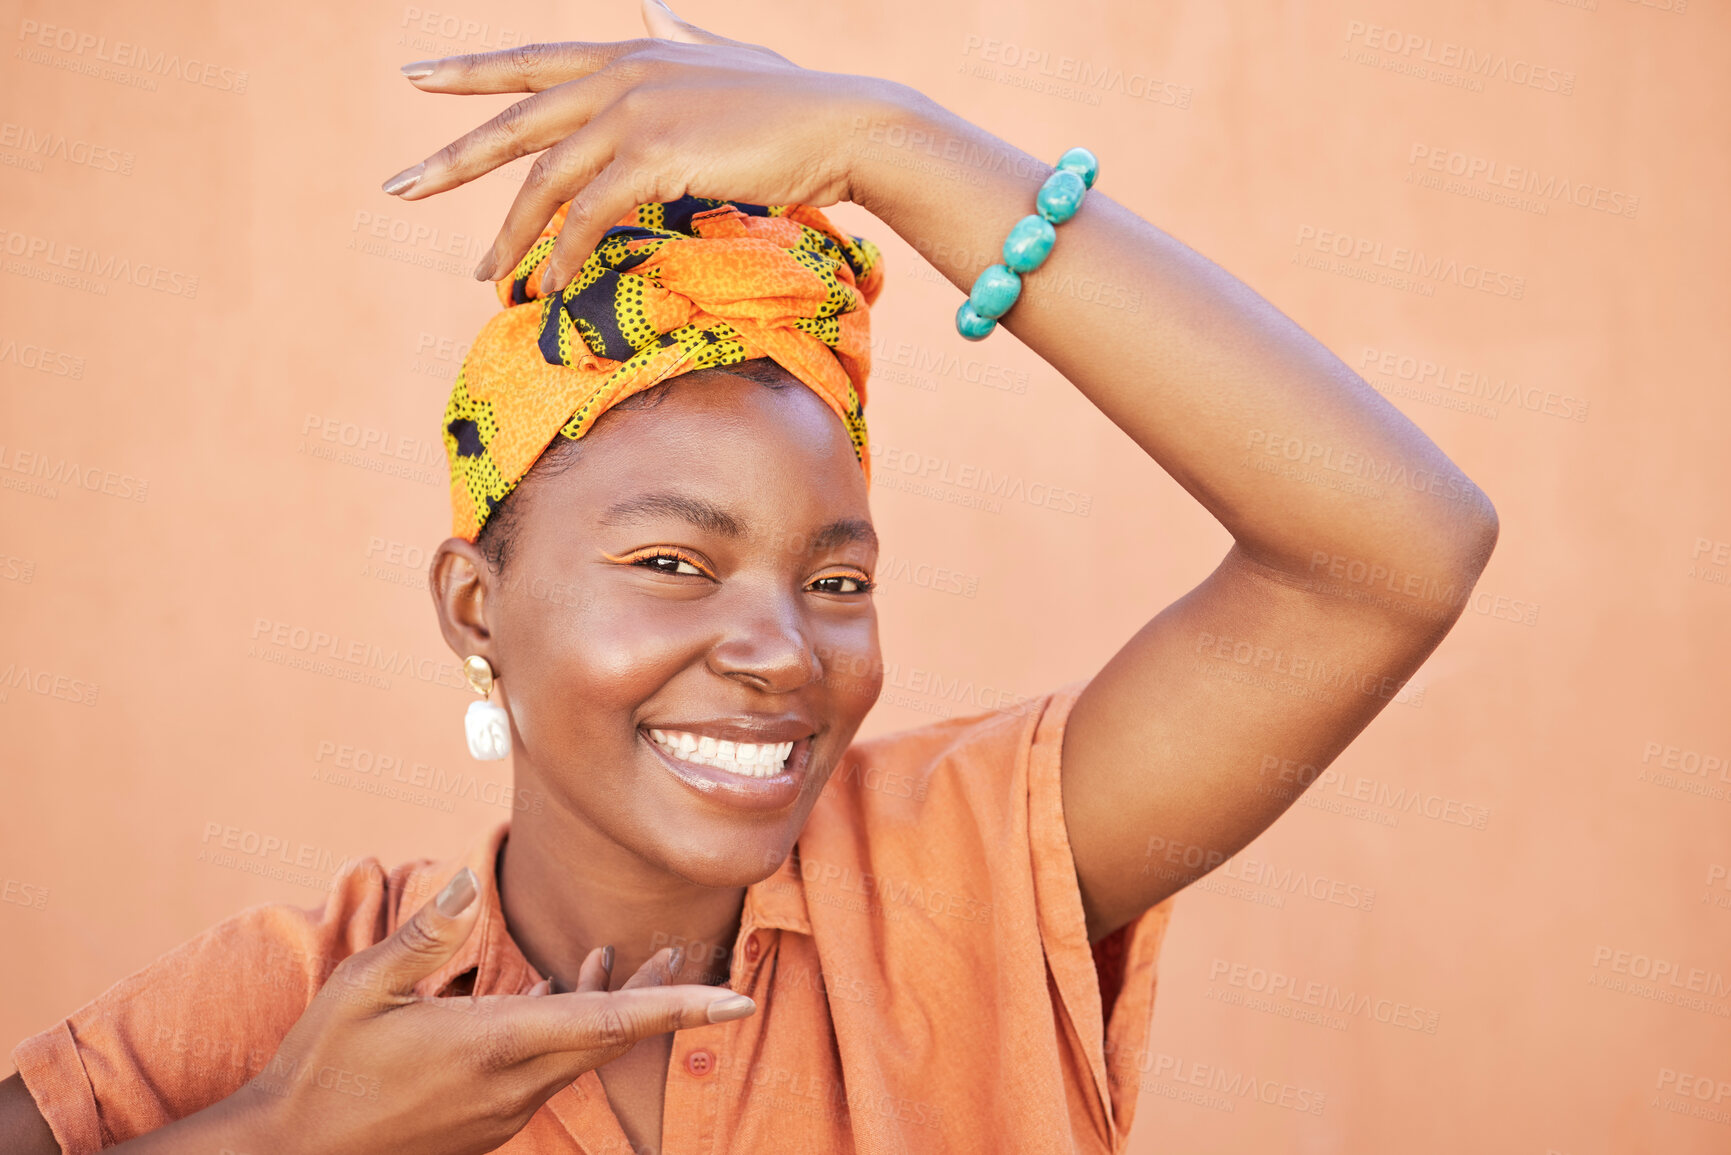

{"left": 515, "top": 372, "right": 871, "bottom": 537}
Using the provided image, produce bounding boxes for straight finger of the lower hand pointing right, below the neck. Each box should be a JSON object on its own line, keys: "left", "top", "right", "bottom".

{"left": 505, "top": 984, "right": 756, "bottom": 1061}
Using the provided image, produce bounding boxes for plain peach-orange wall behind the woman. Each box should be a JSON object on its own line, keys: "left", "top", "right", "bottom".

{"left": 0, "top": 0, "right": 1731, "bottom": 1155}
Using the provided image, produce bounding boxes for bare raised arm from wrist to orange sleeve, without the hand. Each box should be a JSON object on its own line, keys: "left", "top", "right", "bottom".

{"left": 852, "top": 88, "right": 1497, "bottom": 939}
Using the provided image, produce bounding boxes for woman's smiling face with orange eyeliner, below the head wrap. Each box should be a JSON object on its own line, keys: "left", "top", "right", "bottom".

{"left": 447, "top": 371, "right": 883, "bottom": 887}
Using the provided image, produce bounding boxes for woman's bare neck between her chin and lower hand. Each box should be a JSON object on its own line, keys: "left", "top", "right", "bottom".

{"left": 499, "top": 791, "right": 746, "bottom": 990}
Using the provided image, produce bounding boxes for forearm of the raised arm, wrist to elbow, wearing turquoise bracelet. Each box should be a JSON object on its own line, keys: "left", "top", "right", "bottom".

{"left": 850, "top": 85, "right": 1494, "bottom": 588}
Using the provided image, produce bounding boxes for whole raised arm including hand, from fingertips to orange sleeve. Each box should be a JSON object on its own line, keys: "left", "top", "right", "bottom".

{"left": 384, "top": 0, "right": 1497, "bottom": 939}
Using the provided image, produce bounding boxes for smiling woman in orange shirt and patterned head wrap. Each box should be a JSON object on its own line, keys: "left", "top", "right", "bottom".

{"left": 0, "top": 0, "right": 1497, "bottom": 1153}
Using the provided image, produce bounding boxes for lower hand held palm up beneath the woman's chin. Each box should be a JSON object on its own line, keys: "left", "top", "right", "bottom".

{"left": 228, "top": 869, "right": 756, "bottom": 1155}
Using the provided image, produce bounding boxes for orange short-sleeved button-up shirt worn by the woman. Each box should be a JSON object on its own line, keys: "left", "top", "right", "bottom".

{"left": 12, "top": 684, "right": 1170, "bottom": 1155}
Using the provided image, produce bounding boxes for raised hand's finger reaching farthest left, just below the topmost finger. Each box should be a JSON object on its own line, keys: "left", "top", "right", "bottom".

{"left": 383, "top": 73, "right": 625, "bottom": 202}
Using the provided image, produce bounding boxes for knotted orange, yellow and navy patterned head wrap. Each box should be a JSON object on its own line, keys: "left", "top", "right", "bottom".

{"left": 445, "top": 197, "right": 883, "bottom": 542}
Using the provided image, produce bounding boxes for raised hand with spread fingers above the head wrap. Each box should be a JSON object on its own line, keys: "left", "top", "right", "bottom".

{"left": 384, "top": 0, "right": 898, "bottom": 289}
